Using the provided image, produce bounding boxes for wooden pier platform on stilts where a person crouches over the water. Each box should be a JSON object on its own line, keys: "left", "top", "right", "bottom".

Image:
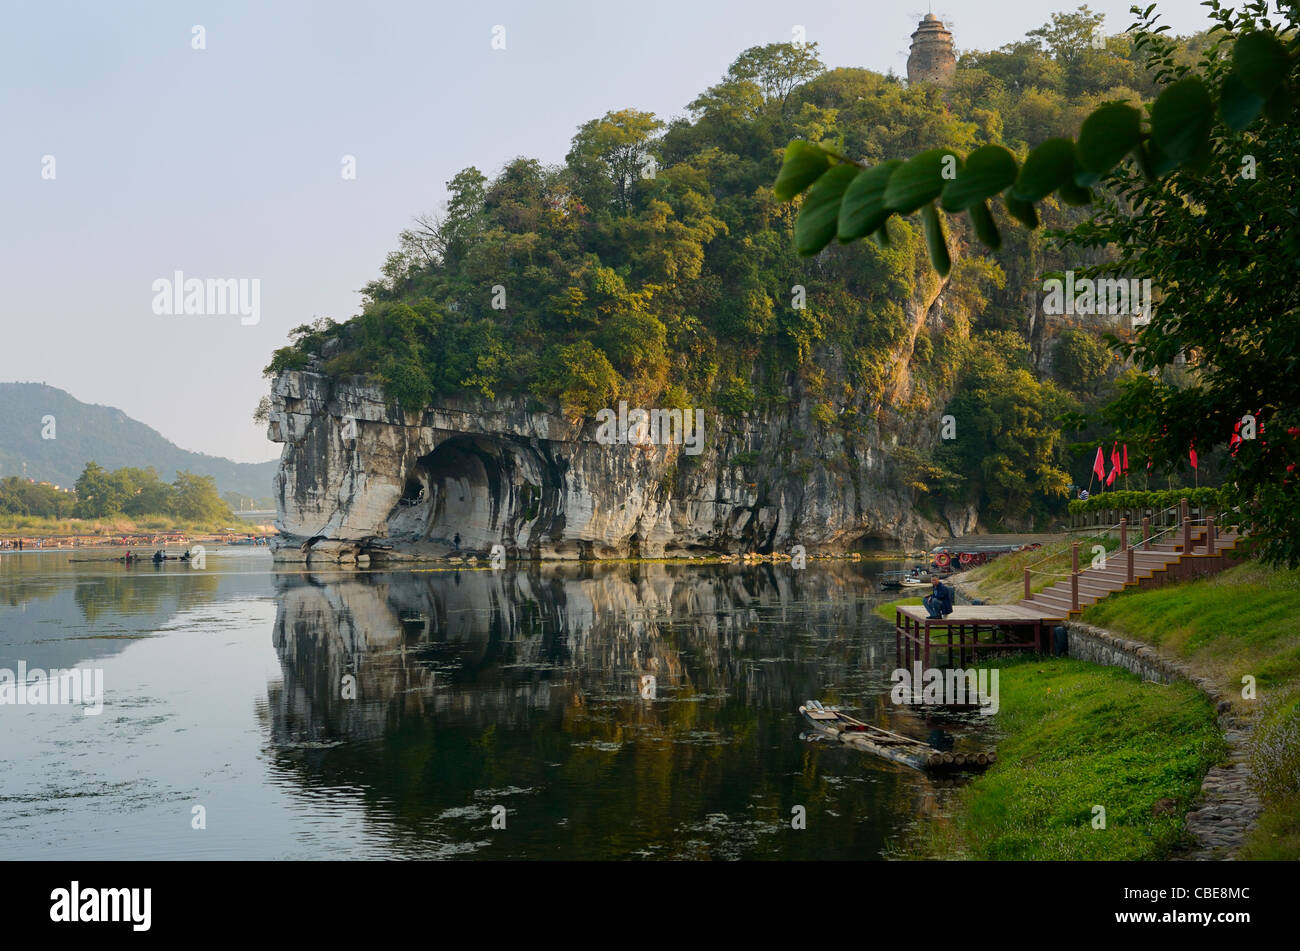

{"left": 894, "top": 604, "right": 1066, "bottom": 666}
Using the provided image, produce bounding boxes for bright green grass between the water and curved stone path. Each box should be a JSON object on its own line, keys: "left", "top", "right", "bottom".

{"left": 922, "top": 657, "right": 1225, "bottom": 860}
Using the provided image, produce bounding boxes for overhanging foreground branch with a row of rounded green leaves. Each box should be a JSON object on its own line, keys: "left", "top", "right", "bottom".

{"left": 774, "top": 3, "right": 1300, "bottom": 277}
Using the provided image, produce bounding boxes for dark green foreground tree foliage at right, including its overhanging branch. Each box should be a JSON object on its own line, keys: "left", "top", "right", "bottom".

{"left": 776, "top": 0, "right": 1300, "bottom": 566}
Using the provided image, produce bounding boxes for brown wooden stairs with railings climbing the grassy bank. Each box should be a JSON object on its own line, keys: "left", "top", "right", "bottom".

{"left": 1017, "top": 525, "right": 1240, "bottom": 621}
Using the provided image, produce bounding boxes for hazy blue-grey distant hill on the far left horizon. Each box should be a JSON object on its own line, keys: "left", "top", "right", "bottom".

{"left": 0, "top": 383, "right": 276, "bottom": 499}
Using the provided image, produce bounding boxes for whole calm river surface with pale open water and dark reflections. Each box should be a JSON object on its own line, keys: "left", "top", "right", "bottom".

{"left": 0, "top": 550, "right": 987, "bottom": 859}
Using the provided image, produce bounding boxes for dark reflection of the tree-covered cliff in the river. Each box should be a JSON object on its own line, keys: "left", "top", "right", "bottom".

{"left": 268, "top": 564, "right": 972, "bottom": 857}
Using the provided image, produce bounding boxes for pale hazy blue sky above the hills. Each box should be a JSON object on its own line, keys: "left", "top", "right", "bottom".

{"left": 0, "top": 0, "right": 1206, "bottom": 461}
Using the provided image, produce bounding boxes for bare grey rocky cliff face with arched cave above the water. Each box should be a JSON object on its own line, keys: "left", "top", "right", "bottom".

{"left": 269, "top": 278, "right": 975, "bottom": 563}
